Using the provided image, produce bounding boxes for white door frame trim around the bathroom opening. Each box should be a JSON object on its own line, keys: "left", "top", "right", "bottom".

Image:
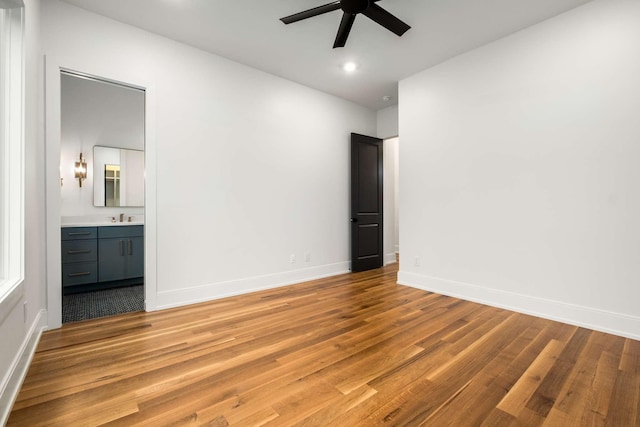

{"left": 43, "top": 55, "right": 157, "bottom": 329}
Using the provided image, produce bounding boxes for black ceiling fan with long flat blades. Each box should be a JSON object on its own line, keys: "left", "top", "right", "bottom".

{"left": 280, "top": 0, "right": 411, "bottom": 49}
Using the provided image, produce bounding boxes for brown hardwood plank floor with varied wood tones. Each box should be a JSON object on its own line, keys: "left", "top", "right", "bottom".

{"left": 8, "top": 265, "right": 640, "bottom": 427}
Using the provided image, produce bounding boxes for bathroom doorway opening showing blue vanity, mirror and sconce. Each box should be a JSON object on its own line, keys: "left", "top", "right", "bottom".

{"left": 60, "top": 71, "right": 145, "bottom": 323}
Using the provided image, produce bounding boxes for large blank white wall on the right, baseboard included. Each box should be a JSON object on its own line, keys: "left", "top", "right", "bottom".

{"left": 400, "top": 0, "right": 640, "bottom": 339}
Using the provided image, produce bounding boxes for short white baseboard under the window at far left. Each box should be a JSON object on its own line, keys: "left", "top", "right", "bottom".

{"left": 0, "top": 309, "right": 47, "bottom": 425}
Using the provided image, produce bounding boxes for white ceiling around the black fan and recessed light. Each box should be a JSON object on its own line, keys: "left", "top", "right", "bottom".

{"left": 58, "top": 0, "right": 590, "bottom": 110}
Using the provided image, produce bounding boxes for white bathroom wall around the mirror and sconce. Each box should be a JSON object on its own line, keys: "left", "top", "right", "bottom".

{"left": 60, "top": 74, "right": 145, "bottom": 222}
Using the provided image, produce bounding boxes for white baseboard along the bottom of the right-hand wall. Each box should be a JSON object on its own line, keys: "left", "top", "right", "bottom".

{"left": 398, "top": 271, "right": 640, "bottom": 340}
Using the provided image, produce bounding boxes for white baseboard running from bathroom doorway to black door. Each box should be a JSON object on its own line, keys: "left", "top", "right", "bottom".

{"left": 157, "top": 262, "right": 349, "bottom": 310}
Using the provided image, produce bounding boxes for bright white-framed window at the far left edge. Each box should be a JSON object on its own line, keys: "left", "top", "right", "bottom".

{"left": 0, "top": 0, "right": 24, "bottom": 301}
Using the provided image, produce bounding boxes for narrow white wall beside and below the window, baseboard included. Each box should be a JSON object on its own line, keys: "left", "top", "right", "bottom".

{"left": 0, "top": 0, "right": 46, "bottom": 424}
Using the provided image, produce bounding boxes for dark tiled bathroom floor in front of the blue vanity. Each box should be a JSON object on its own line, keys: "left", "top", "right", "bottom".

{"left": 62, "top": 285, "right": 144, "bottom": 323}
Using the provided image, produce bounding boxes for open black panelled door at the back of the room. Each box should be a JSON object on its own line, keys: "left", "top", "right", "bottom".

{"left": 351, "top": 133, "right": 383, "bottom": 271}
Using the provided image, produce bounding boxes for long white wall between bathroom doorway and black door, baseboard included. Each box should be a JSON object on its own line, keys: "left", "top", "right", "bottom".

{"left": 43, "top": 0, "right": 376, "bottom": 308}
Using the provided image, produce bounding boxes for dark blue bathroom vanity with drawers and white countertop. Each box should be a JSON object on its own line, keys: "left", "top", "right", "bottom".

{"left": 61, "top": 223, "right": 144, "bottom": 294}
